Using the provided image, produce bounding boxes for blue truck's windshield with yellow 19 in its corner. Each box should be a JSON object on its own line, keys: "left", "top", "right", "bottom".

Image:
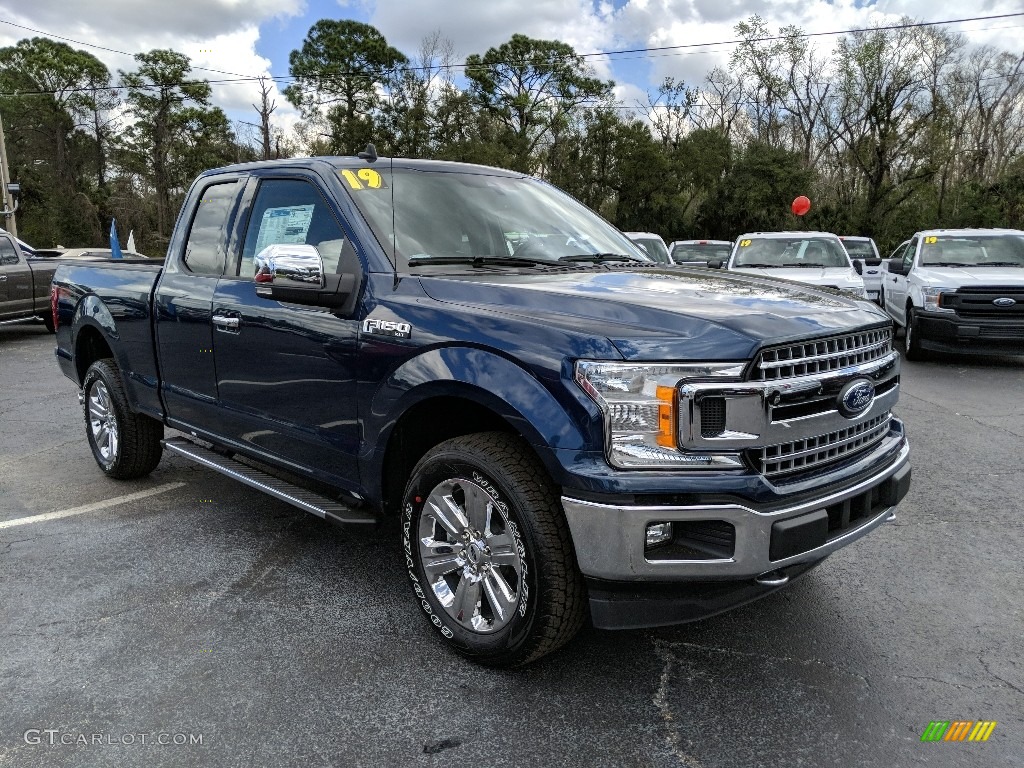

{"left": 339, "top": 166, "right": 648, "bottom": 270}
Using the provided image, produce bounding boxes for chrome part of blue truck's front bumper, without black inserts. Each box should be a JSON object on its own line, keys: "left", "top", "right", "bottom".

{"left": 562, "top": 442, "right": 910, "bottom": 582}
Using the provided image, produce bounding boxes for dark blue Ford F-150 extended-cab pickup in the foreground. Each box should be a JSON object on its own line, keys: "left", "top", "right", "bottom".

{"left": 52, "top": 151, "right": 910, "bottom": 667}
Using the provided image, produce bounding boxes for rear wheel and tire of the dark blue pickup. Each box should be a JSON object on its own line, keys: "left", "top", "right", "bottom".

{"left": 82, "top": 358, "right": 164, "bottom": 480}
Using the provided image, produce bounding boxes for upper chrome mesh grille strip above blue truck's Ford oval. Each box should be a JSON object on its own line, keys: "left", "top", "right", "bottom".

{"left": 751, "top": 328, "right": 893, "bottom": 381}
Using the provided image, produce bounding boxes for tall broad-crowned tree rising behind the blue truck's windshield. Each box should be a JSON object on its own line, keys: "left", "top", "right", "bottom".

{"left": 466, "top": 35, "right": 614, "bottom": 172}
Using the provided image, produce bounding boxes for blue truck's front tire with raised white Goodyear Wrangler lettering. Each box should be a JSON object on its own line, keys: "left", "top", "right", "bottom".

{"left": 401, "top": 432, "right": 587, "bottom": 668}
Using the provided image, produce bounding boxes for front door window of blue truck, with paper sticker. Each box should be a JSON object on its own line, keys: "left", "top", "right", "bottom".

{"left": 239, "top": 179, "right": 354, "bottom": 278}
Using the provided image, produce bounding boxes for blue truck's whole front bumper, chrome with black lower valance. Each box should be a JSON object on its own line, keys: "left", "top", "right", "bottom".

{"left": 562, "top": 439, "right": 910, "bottom": 629}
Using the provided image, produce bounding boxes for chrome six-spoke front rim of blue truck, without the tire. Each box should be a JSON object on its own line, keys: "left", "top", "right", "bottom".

{"left": 417, "top": 478, "right": 523, "bottom": 633}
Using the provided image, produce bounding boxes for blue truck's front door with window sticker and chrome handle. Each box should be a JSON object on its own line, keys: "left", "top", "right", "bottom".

{"left": 213, "top": 171, "right": 362, "bottom": 488}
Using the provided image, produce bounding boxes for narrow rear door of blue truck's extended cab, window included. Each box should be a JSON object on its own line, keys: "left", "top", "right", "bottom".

{"left": 154, "top": 176, "right": 243, "bottom": 433}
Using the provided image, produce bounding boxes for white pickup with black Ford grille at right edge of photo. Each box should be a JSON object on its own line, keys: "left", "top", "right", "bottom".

{"left": 882, "top": 229, "right": 1024, "bottom": 360}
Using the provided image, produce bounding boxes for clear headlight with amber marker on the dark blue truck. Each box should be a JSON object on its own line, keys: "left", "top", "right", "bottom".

{"left": 575, "top": 360, "right": 745, "bottom": 469}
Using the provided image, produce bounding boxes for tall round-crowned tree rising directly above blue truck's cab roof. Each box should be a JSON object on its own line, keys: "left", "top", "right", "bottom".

{"left": 285, "top": 18, "right": 408, "bottom": 155}
